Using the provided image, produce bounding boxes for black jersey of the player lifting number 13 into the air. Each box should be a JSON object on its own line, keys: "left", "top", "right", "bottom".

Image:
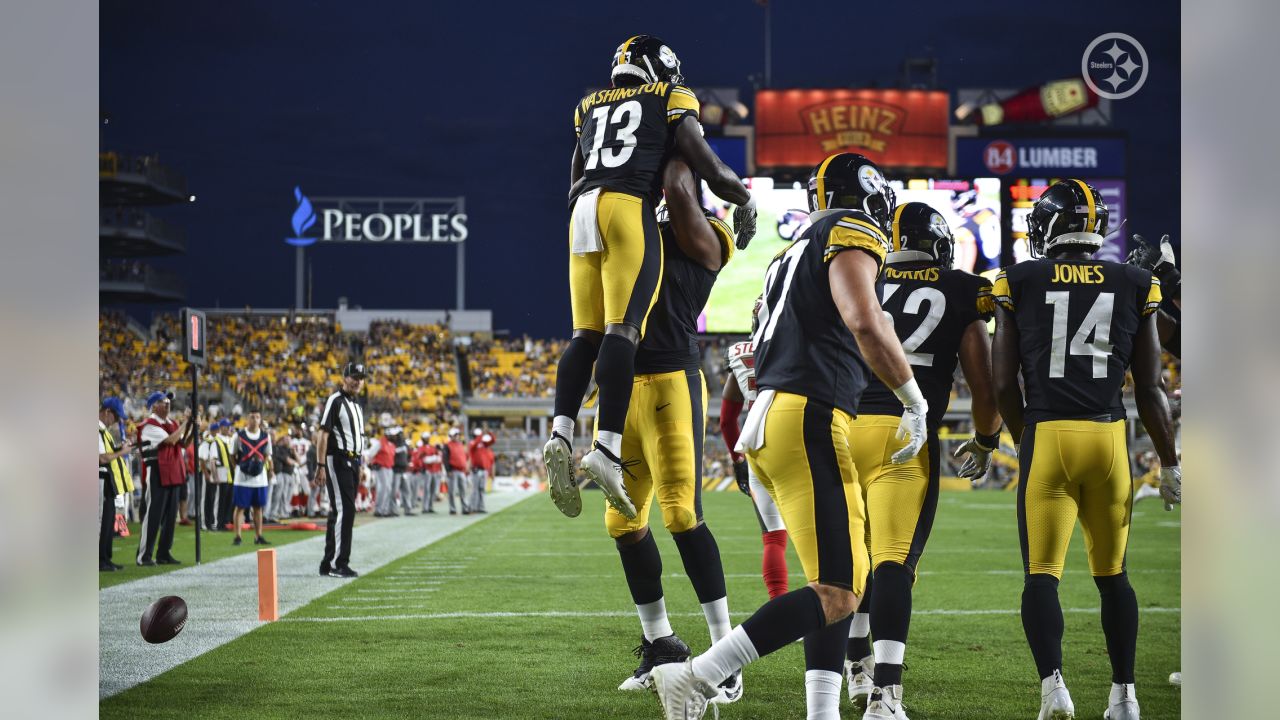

{"left": 635, "top": 219, "right": 733, "bottom": 375}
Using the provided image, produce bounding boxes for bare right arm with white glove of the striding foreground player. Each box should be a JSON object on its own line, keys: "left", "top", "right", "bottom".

{"left": 828, "top": 246, "right": 929, "bottom": 464}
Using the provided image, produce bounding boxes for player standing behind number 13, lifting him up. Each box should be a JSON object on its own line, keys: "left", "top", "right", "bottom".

{"left": 614, "top": 158, "right": 742, "bottom": 702}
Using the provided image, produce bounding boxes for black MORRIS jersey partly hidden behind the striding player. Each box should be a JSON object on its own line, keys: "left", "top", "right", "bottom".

{"left": 859, "top": 266, "right": 996, "bottom": 429}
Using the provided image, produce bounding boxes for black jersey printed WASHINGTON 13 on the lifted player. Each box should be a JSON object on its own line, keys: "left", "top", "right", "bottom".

{"left": 570, "top": 82, "right": 699, "bottom": 208}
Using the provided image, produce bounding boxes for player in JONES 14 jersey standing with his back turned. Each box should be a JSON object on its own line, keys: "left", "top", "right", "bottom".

{"left": 992, "top": 179, "right": 1181, "bottom": 720}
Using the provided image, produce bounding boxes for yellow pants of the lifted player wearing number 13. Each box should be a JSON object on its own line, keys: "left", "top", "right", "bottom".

{"left": 568, "top": 192, "right": 662, "bottom": 337}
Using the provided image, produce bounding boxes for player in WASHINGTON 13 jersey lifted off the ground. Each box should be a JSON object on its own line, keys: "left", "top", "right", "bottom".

{"left": 543, "top": 35, "right": 755, "bottom": 519}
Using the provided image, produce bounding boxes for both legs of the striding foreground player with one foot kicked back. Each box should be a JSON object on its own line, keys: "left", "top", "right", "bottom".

{"left": 654, "top": 393, "right": 868, "bottom": 719}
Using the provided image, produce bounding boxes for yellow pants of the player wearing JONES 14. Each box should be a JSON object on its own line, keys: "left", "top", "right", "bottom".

{"left": 1018, "top": 420, "right": 1133, "bottom": 579}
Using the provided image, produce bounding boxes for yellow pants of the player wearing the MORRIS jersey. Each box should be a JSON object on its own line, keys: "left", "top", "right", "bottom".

{"left": 849, "top": 415, "right": 940, "bottom": 573}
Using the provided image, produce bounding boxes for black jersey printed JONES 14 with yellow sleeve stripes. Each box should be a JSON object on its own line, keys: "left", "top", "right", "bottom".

{"left": 992, "top": 258, "right": 1160, "bottom": 423}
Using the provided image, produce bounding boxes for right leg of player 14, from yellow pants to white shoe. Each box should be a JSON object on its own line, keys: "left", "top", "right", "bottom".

{"left": 1069, "top": 420, "right": 1138, "bottom": 720}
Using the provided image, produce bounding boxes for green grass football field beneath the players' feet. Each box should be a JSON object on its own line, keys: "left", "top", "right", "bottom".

{"left": 101, "top": 492, "right": 1181, "bottom": 720}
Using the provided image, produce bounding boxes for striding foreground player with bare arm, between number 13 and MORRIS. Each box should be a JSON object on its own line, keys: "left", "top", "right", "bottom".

{"left": 653, "top": 152, "right": 928, "bottom": 720}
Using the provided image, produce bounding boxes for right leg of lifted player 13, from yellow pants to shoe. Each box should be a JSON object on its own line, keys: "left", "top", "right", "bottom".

{"left": 582, "top": 192, "right": 662, "bottom": 515}
